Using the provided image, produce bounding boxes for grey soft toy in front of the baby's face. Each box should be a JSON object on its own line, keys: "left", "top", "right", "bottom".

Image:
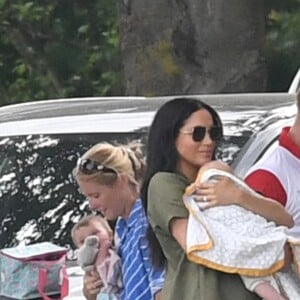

{"left": 77, "top": 235, "right": 99, "bottom": 272}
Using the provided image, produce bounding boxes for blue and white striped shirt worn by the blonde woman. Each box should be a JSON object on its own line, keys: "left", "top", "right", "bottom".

{"left": 116, "top": 199, "right": 164, "bottom": 300}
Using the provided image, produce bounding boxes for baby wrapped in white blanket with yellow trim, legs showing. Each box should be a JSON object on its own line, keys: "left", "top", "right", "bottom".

{"left": 183, "top": 161, "right": 300, "bottom": 300}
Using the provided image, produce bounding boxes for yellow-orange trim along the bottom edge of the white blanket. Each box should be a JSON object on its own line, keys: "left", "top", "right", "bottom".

{"left": 187, "top": 252, "right": 284, "bottom": 277}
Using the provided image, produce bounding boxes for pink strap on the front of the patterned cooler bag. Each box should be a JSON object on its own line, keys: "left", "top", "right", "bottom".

{"left": 38, "top": 266, "right": 69, "bottom": 300}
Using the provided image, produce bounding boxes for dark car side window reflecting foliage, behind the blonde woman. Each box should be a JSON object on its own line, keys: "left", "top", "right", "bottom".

{"left": 0, "top": 132, "right": 144, "bottom": 248}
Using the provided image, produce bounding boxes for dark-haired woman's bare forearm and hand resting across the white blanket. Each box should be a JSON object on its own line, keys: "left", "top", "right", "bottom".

{"left": 197, "top": 178, "right": 294, "bottom": 227}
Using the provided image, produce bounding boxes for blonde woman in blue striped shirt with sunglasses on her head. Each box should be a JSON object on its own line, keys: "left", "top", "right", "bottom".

{"left": 74, "top": 143, "right": 164, "bottom": 300}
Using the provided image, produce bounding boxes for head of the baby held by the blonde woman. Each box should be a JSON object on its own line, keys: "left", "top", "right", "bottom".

{"left": 71, "top": 215, "right": 113, "bottom": 248}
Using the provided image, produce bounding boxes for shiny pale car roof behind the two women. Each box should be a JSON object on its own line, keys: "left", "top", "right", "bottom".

{"left": 0, "top": 93, "right": 295, "bottom": 136}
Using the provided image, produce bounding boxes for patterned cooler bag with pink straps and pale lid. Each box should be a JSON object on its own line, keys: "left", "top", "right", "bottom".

{"left": 0, "top": 242, "right": 69, "bottom": 300}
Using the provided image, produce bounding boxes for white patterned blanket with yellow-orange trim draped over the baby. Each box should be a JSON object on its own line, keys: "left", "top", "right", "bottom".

{"left": 183, "top": 169, "right": 300, "bottom": 299}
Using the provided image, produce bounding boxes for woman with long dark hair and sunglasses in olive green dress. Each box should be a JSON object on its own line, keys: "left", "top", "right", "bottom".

{"left": 142, "top": 98, "right": 292, "bottom": 300}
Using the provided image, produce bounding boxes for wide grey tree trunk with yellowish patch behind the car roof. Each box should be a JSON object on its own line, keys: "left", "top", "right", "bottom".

{"left": 117, "top": 0, "right": 266, "bottom": 96}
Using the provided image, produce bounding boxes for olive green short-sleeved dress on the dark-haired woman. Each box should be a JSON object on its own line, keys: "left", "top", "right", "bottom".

{"left": 148, "top": 172, "right": 260, "bottom": 300}
